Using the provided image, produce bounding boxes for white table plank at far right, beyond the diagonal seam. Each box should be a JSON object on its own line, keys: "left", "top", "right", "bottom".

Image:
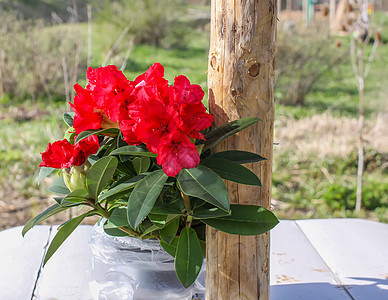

{"left": 297, "top": 219, "right": 388, "bottom": 300}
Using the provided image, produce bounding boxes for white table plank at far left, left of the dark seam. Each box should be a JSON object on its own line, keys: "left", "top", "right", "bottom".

{"left": 0, "top": 226, "right": 50, "bottom": 300}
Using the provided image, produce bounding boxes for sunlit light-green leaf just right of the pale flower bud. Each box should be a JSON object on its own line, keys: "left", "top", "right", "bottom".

{"left": 86, "top": 156, "right": 118, "bottom": 199}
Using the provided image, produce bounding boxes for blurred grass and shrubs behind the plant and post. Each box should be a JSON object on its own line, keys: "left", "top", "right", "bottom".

{"left": 0, "top": 0, "right": 388, "bottom": 228}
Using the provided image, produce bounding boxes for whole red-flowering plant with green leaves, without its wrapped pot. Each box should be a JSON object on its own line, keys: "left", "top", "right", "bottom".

{"left": 23, "top": 63, "right": 278, "bottom": 296}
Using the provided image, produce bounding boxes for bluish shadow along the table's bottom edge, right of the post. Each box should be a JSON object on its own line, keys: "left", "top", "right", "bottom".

{"left": 271, "top": 274, "right": 388, "bottom": 300}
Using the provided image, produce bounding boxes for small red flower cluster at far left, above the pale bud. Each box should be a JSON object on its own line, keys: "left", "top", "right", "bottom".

{"left": 39, "top": 135, "right": 100, "bottom": 169}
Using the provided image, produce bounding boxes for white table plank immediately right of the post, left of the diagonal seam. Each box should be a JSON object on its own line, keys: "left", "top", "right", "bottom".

{"left": 271, "top": 221, "right": 350, "bottom": 300}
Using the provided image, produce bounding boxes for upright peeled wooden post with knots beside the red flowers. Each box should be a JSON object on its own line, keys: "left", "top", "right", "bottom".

{"left": 206, "top": 0, "right": 277, "bottom": 300}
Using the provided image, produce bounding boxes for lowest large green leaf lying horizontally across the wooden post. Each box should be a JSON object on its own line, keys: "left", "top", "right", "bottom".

{"left": 202, "top": 205, "right": 279, "bottom": 235}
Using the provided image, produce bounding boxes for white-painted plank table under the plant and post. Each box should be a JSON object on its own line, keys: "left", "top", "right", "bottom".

{"left": 0, "top": 219, "right": 388, "bottom": 300}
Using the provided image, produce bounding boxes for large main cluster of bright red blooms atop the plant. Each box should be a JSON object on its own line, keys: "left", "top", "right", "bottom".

{"left": 71, "top": 63, "right": 213, "bottom": 176}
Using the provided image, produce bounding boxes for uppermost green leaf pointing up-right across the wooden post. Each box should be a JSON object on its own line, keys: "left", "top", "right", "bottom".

{"left": 202, "top": 118, "right": 260, "bottom": 151}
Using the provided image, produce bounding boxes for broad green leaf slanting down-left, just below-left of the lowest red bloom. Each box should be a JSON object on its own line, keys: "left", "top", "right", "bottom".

{"left": 128, "top": 170, "right": 168, "bottom": 229}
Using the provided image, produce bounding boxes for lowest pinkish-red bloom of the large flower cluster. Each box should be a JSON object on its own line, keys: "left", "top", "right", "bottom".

{"left": 157, "top": 130, "right": 200, "bottom": 177}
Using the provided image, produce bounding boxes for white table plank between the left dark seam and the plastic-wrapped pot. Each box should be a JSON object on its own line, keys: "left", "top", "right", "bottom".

{"left": 34, "top": 226, "right": 93, "bottom": 300}
